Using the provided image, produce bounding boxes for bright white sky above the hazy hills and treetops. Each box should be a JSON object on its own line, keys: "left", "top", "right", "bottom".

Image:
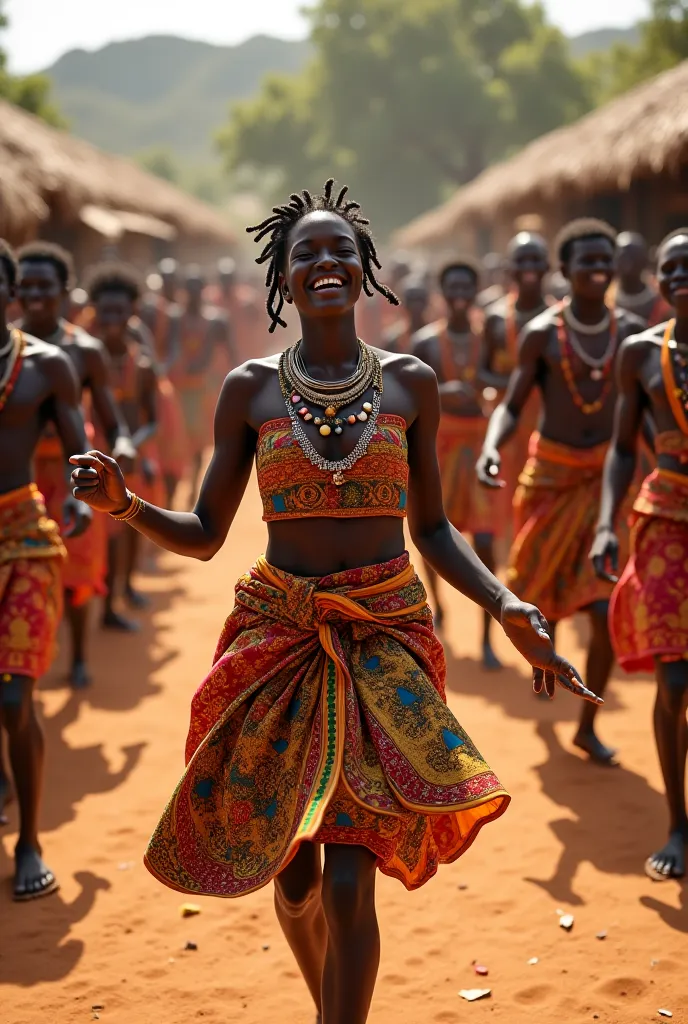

{"left": 4, "top": 0, "right": 648, "bottom": 72}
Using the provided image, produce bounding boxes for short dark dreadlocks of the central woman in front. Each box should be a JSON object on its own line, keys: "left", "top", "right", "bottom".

{"left": 247, "top": 178, "right": 399, "bottom": 334}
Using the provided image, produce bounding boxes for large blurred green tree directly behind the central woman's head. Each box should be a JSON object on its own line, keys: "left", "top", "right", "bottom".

{"left": 218, "top": 0, "right": 590, "bottom": 230}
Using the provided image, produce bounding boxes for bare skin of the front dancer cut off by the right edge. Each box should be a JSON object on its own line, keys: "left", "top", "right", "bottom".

{"left": 591, "top": 233, "right": 688, "bottom": 879}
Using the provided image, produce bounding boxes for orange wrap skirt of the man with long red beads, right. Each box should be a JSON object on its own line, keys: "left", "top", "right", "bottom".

{"left": 507, "top": 433, "right": 628, "bottom": 623}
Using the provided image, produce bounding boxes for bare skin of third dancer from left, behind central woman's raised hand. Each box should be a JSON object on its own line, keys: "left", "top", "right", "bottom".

{"left": 93, "top": 289, "right": 158, "bottom": 632}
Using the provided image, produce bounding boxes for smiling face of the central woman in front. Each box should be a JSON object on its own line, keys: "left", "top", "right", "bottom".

{"left": 281, "top": 210, "right": 363, "bottom": 318}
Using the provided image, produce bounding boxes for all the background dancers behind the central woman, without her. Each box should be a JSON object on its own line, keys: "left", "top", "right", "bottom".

{"left": 0, "top": 209, "right": 688, "bottom": 913}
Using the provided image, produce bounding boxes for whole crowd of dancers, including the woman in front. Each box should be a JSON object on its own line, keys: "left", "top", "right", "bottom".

{"left": 0, "top": 182, "right": 688, "bottom": 1024}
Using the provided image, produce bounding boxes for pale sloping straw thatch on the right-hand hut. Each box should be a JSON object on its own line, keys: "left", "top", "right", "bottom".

{"left": 395, "top": 60, "right": 688, "bottom": 247}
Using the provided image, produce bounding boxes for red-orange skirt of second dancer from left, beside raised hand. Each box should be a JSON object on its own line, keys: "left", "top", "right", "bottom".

{"left": 34, "top": 423, "right": 108, "bottom": 607}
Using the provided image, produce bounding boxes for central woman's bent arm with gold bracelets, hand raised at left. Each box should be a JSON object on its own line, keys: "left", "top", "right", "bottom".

{"left": 72, "top": 365, "right": 256, "bottom": 561}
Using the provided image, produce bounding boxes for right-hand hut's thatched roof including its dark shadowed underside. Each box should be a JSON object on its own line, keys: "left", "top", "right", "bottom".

{"left": 396, "top": 60, "right": 688, "bottom": 248}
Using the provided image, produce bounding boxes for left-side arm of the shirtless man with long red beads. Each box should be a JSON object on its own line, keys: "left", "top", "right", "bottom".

{"left": 476, "top": 325, "right": 547, "bottom": 487}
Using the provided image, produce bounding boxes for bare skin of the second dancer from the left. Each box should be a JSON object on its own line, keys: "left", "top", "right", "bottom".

{"left": 16, "top": 260, "right": 136, "bottom": 688}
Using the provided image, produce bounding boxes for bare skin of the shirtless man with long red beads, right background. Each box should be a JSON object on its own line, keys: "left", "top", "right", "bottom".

{"left": 477, "top": 238, "right": 642, "bottom": 764}
